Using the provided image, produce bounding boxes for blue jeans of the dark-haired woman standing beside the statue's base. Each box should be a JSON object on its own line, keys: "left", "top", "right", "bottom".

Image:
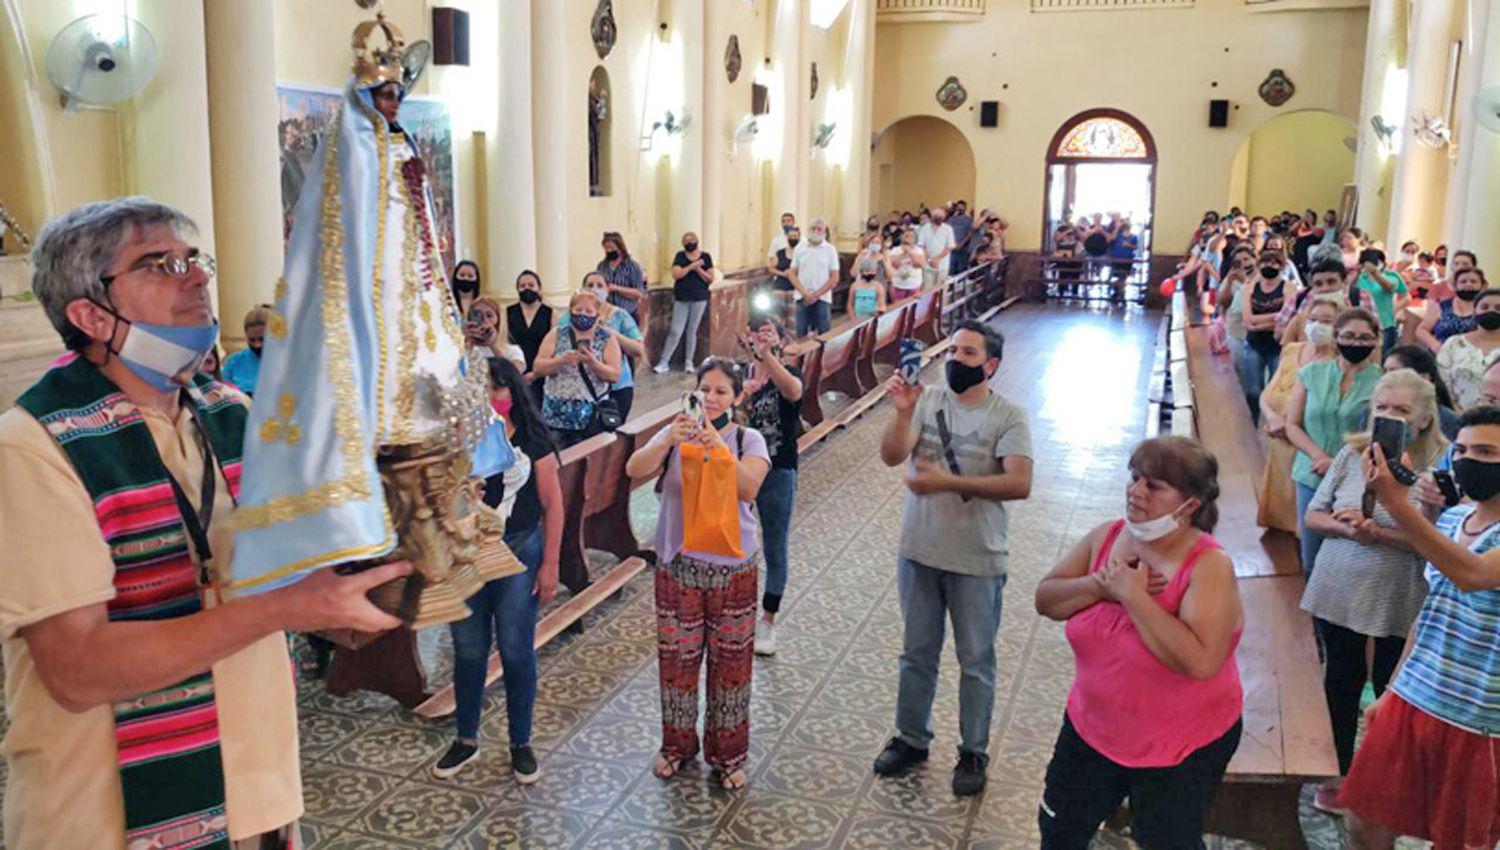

{"left": 449, "top": 525, "right": 546, "bottom": 747}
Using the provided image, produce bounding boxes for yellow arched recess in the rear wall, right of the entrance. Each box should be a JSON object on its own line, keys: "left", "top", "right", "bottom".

{"left": 1229, "top": 109, "right": 1358, "bottom": 216}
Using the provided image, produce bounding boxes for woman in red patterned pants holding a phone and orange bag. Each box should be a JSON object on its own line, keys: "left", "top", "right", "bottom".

{"left": 626, "top": 358, "right": 771, "bottom": 790}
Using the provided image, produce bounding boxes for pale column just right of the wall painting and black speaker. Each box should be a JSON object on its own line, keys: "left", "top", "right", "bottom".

{"left": 485, "top": 0, "right": 537, "bottom": 300}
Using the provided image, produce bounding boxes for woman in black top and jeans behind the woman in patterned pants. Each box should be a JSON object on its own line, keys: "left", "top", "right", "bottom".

{"left": 744, "top": 316, "right": 803, "bottom": 655}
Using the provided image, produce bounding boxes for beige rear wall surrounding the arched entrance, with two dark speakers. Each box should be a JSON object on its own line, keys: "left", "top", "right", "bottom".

{"left": 873, "top": 0, "right": 1368, "bottom": 249}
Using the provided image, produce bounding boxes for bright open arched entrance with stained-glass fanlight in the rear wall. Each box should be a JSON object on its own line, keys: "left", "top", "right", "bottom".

{"left": 1043, "top": 109, "right": 1157, "bottom": 300}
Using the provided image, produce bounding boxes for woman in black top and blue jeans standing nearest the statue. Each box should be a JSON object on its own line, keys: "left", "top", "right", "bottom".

{"left": 432, "top": 357, "right": 563, "bottom": 786}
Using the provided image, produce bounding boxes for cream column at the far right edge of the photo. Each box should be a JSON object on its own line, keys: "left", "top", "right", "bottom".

{"left": 1449, "top": 3, "right": 1500, "bottom": 262}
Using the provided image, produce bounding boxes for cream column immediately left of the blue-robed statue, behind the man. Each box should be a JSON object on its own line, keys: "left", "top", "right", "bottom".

{"left": 201, "top": 0, "right": 282, "bottom": 349}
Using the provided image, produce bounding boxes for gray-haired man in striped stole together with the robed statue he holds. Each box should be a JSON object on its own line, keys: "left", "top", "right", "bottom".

{"left": 0, "top": 8, "right": 521, "bottom": 850}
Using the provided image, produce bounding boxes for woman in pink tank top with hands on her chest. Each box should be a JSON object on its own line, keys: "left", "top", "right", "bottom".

{"left": 1037, "top": 436, "right": 1245, "bottom": 850}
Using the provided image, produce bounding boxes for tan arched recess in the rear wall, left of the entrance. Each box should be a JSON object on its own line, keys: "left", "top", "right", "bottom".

{"left": 870, "top": 115, "right": 974, "bottom": 214}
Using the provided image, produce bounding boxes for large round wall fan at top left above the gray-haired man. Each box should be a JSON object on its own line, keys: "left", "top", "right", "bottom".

{"left": 47, "top": 15, "right": 156, "bottom": 111}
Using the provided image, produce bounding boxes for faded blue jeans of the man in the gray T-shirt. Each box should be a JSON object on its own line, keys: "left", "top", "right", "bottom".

{"left": 896, "top": 558, "right": 1005, "bottom": 753}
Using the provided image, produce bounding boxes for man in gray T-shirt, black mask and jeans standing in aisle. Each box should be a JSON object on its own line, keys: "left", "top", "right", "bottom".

{"left": 875, "top": 321, "right": 1032, "bottom": 796}
